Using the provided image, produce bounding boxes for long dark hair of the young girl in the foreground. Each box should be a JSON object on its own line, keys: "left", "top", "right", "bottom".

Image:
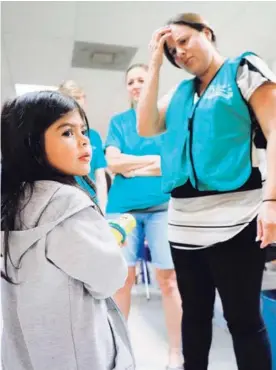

{"left": 1, "top": 91, "right": 96, "bottom": 282}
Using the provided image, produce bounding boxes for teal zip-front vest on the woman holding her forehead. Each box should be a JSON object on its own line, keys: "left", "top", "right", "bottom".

{"left": 161, "top": 53, "right": 252, "bottom": 192}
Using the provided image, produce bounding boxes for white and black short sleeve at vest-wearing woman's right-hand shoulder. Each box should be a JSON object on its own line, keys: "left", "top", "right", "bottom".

{"left": 237, "top": 55, "right": 276, "bottom": 102}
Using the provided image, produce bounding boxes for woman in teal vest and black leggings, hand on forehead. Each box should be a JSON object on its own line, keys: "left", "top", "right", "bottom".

{"left": 137, "top": 14, "right": 276, "bottom": 370}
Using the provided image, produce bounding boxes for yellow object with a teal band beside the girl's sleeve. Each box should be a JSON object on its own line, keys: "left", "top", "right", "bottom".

{"left": 109, "top": 213, "right": 136, "bottom": 244}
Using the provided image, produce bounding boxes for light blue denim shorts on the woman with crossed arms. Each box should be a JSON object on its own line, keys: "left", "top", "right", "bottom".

{"left": 107, "top": 211, "right": 174, "bottom": 270}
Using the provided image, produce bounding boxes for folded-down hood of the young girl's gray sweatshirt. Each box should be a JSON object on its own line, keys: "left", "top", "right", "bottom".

{"left": 1, "top": 181, "right": 95, "bottom": 266}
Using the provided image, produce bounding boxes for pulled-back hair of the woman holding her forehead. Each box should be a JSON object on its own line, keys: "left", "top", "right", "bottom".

{"left": 164, "top": 13, "right": 216, "bottom": 68}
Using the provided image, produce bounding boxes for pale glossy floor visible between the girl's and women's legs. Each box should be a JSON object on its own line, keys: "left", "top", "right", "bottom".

{"left": 129, "top": 287, "right": 237, "bottom": 370}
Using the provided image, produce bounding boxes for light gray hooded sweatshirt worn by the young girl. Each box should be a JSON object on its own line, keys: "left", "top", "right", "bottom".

{"left": 1, "top": 181, "right": 135, "bottom": 370}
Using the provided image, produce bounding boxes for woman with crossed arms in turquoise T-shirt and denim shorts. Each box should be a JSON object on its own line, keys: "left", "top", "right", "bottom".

{"left": 106, "top": 64, "right": 183, "bottom": 370}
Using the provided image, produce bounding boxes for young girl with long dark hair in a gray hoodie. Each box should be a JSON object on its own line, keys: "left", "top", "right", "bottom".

{"left": 1, "top": 92, "right": 135, "bottom": 370}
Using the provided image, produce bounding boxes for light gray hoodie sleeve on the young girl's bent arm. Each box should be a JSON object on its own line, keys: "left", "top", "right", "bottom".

{"left": 46, "top": 207, "right": 127, "bottom": 299}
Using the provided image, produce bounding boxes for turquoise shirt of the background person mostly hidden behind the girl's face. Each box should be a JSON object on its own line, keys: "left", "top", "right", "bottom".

{"left": 76, "top": 129, "right": 107, "bottom": 196}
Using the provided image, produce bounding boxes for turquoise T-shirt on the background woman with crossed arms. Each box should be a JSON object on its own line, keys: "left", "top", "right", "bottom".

{"left": 105, "top": 109, "right": 169, "bottom": 213}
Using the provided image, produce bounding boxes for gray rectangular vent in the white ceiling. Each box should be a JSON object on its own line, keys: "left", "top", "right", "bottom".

{"left": 72, "top": 41, "right": 138, "bottom": 71}
